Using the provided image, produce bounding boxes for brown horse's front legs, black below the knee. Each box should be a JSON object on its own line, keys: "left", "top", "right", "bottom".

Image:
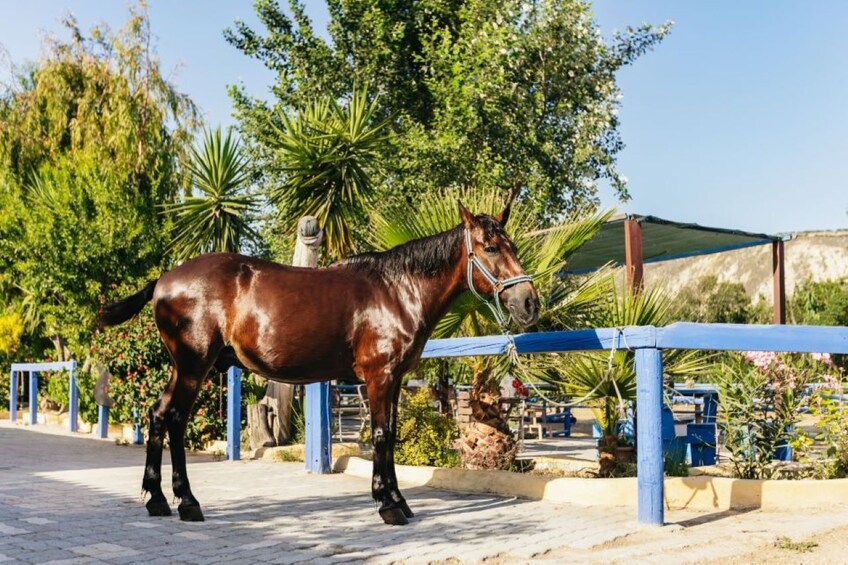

{"left": 366, "top": 376, "right": 408, "bottom": 526}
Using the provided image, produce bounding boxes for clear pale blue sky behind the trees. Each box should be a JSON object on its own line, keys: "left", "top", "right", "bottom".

{"left": 0, "top": 0, "right": 848, "bottom": 232}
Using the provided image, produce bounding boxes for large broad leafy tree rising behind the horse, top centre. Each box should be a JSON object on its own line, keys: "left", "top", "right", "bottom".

{"left": 225, "top": 0, "right": 669, "bottom": 231}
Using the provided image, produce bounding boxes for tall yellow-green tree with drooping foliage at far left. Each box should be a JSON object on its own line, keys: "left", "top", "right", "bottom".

{"left": 0, "top": 6, "right": 197, "bottom": 358}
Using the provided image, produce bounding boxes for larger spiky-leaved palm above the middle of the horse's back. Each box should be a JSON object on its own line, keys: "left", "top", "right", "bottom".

{"left": 271, "top": 89, "right": 389, "bottom": 259}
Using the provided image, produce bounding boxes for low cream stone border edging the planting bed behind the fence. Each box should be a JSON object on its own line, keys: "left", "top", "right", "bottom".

{"left": 333, "top": 456, "right": 848, "bottom": 511}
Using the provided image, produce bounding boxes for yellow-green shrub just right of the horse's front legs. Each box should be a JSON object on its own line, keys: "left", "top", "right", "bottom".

{"left": 395, "top": 388, "right": 459, "bottom": 467}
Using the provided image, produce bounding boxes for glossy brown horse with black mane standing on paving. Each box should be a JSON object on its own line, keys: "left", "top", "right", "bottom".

{"left": 98, "top": 204, "right": 539, "bottom": 524}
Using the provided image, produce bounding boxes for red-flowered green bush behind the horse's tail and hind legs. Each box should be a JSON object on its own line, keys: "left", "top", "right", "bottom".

{"left": 91, "top": 307, "right": 230, "bottom": 449}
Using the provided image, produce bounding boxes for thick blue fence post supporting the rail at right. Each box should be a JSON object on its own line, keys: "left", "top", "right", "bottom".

{"left": 636, "top": 348, "right": 665, "bottom": 526}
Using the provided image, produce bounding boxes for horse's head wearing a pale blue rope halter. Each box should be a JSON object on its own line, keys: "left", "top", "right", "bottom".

{"left": 459, "top": 202, "right": 539, "bottom": 327}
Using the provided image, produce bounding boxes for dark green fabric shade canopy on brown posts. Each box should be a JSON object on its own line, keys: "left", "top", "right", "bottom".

{"left": 565, "top": 214, "right": 787, "bottom": 274}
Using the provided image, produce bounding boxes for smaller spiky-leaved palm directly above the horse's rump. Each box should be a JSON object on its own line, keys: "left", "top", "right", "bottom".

{"left": 166, "top": 127, "right": 258, "bottom": 262}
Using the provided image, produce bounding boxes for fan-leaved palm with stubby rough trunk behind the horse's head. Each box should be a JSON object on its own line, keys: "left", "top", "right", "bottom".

{"left": 371, "top": 189, "right": 610, "bottom": 469}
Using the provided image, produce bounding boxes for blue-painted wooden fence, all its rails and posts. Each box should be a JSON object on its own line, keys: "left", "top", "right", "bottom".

{"left": 9, "top": 323, "right": 848, "bottom": 524}
